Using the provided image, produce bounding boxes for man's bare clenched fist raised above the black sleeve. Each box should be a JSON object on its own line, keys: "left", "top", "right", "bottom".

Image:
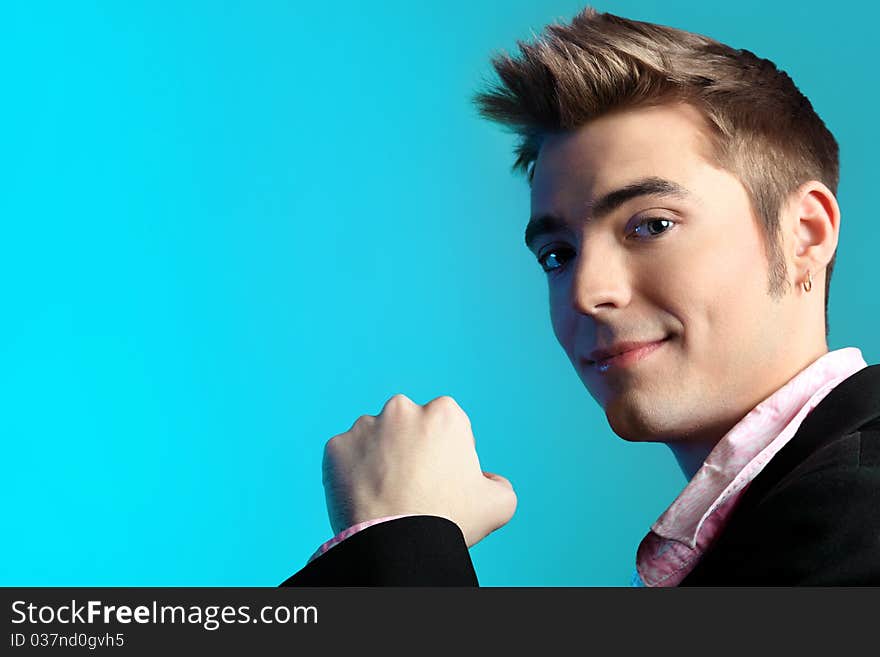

{"left": 323, "top": 394, "right": 516, "bottom": 547}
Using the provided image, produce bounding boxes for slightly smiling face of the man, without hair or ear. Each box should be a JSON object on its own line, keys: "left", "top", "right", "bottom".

{"left": 530, "top": 104, "right": 801, "bottom": 442}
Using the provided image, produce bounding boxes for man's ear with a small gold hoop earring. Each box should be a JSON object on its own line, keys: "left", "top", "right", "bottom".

{"left": 788, "top": 180, "right": 840, "bottom": 287}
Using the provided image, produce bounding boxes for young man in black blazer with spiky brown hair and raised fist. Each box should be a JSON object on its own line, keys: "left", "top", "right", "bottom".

{"left": 284, "top": 3, "right": 880, "bottom": 586}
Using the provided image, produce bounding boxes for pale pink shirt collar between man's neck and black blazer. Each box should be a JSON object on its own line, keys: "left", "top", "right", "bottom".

{"left": 633, "top": 347, "right": 867, "bottom": 586}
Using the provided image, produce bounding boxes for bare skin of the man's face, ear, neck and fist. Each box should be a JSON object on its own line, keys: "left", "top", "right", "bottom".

{"left": 323, "top": 98, "right": 840, "bottom": 546}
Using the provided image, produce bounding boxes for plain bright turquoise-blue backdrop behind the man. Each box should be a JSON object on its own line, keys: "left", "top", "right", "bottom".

{"left": 0, "top": 0, "right": 880, "bottom": 586}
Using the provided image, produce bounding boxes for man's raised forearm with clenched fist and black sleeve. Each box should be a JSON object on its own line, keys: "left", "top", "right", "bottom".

{"left": 282, "top": 395, "right": 517, "bottom": 586}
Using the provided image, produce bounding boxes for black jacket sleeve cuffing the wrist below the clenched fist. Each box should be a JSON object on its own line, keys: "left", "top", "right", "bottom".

{"left": 281, "top": 516, "right": 479, "bottom": 586}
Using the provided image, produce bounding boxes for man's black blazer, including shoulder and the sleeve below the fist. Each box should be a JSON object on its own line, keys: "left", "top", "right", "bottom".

{"left": 281, "top": 365, "right": 880, "bottom": 586}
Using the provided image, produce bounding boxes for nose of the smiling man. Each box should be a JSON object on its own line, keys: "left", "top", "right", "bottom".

{"left": 569, "top": 246, "right": 632, "bottom": 316}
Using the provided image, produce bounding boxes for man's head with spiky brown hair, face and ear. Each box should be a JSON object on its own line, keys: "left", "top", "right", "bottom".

{"left": 476, "top": 8, "right": 839, "bottom": 454}
